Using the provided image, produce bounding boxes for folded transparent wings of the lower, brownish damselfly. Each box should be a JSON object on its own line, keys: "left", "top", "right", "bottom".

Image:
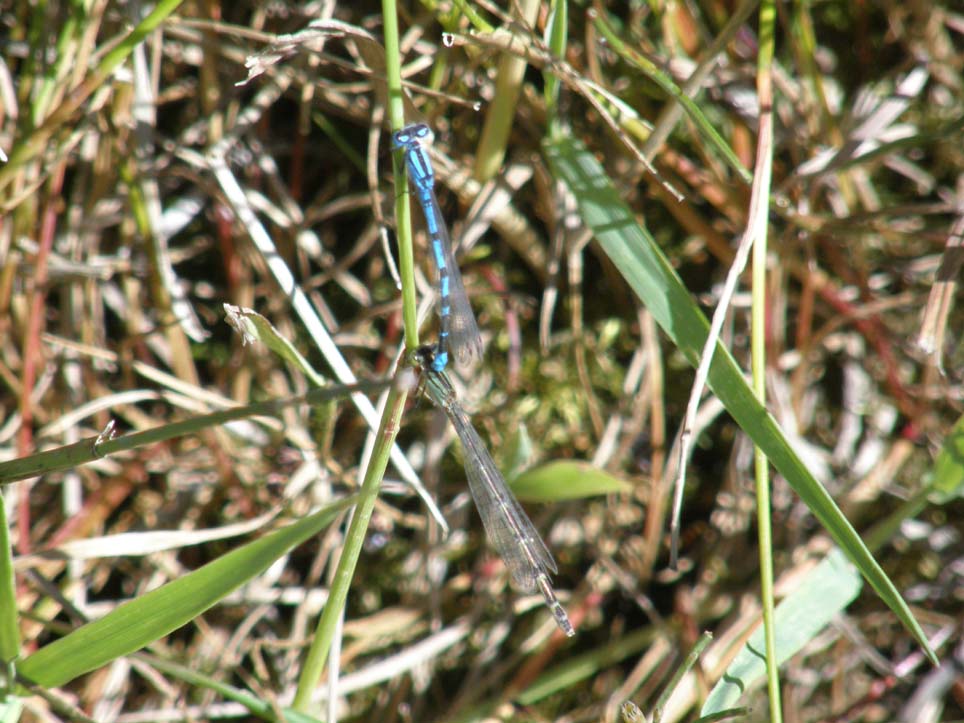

{"left": 443, "top": 400, "right": 557, "bottom": 592}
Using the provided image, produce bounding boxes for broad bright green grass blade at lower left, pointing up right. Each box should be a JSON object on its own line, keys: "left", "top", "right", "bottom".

{"left": 18, "top": 497, "right": 355, "bottom": 688}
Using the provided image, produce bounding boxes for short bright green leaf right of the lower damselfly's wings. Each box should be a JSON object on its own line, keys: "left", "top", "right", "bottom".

{"left": 512, "top": 460, "right": 632, "bottom": 502}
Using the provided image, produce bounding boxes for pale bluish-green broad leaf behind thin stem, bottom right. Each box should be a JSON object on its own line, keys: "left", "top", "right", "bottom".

{"left": 700, "top": 549, "right": 862, "bottom": 716}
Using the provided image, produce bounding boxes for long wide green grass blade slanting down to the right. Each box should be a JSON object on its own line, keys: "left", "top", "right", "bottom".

{"left": 544, "top": 137, "right": 937, "bottom": 664}
